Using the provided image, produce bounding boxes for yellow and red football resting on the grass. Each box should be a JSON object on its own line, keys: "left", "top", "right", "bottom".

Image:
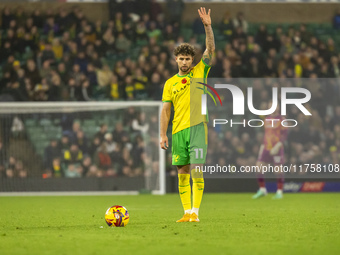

{"left": 105, "top": 205, "right": 130, "bottom": 227}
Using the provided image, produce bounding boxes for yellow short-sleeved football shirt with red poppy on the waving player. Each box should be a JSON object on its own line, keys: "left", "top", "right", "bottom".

{"left": 162, "top": 59, "right": 210, "bottom": 134}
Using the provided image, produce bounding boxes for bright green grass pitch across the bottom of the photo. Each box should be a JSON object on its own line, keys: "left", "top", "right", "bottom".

{"left": 0, "top": 194, "right": 340, "bottom": 255}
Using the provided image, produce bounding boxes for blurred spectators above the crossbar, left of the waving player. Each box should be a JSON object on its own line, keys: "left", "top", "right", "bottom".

{"left": 0, "top": 1, "right": 186, "bottom": 101}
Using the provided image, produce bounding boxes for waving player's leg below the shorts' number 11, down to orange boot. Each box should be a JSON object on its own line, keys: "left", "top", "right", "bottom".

{"left": 190, "top": 123, "right": 208, "bottom": 222}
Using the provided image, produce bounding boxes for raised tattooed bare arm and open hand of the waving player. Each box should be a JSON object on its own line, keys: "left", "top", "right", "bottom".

{"left": 198, "top": 7, "right": 215, "bottom": 66}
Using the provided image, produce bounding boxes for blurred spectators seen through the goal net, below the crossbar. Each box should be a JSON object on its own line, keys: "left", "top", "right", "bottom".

{"left": 0, "top": 107, "right": 159, "bottom": 178}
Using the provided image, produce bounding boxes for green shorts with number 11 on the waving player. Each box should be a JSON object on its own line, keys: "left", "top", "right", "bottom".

{"left": 171, "top": 122, "right": 208, "bottom": 166}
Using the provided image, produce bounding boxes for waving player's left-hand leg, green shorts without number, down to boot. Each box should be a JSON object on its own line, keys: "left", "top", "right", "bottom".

{"left": 172, "top": 129, "right": 191, "bottom": 222}
